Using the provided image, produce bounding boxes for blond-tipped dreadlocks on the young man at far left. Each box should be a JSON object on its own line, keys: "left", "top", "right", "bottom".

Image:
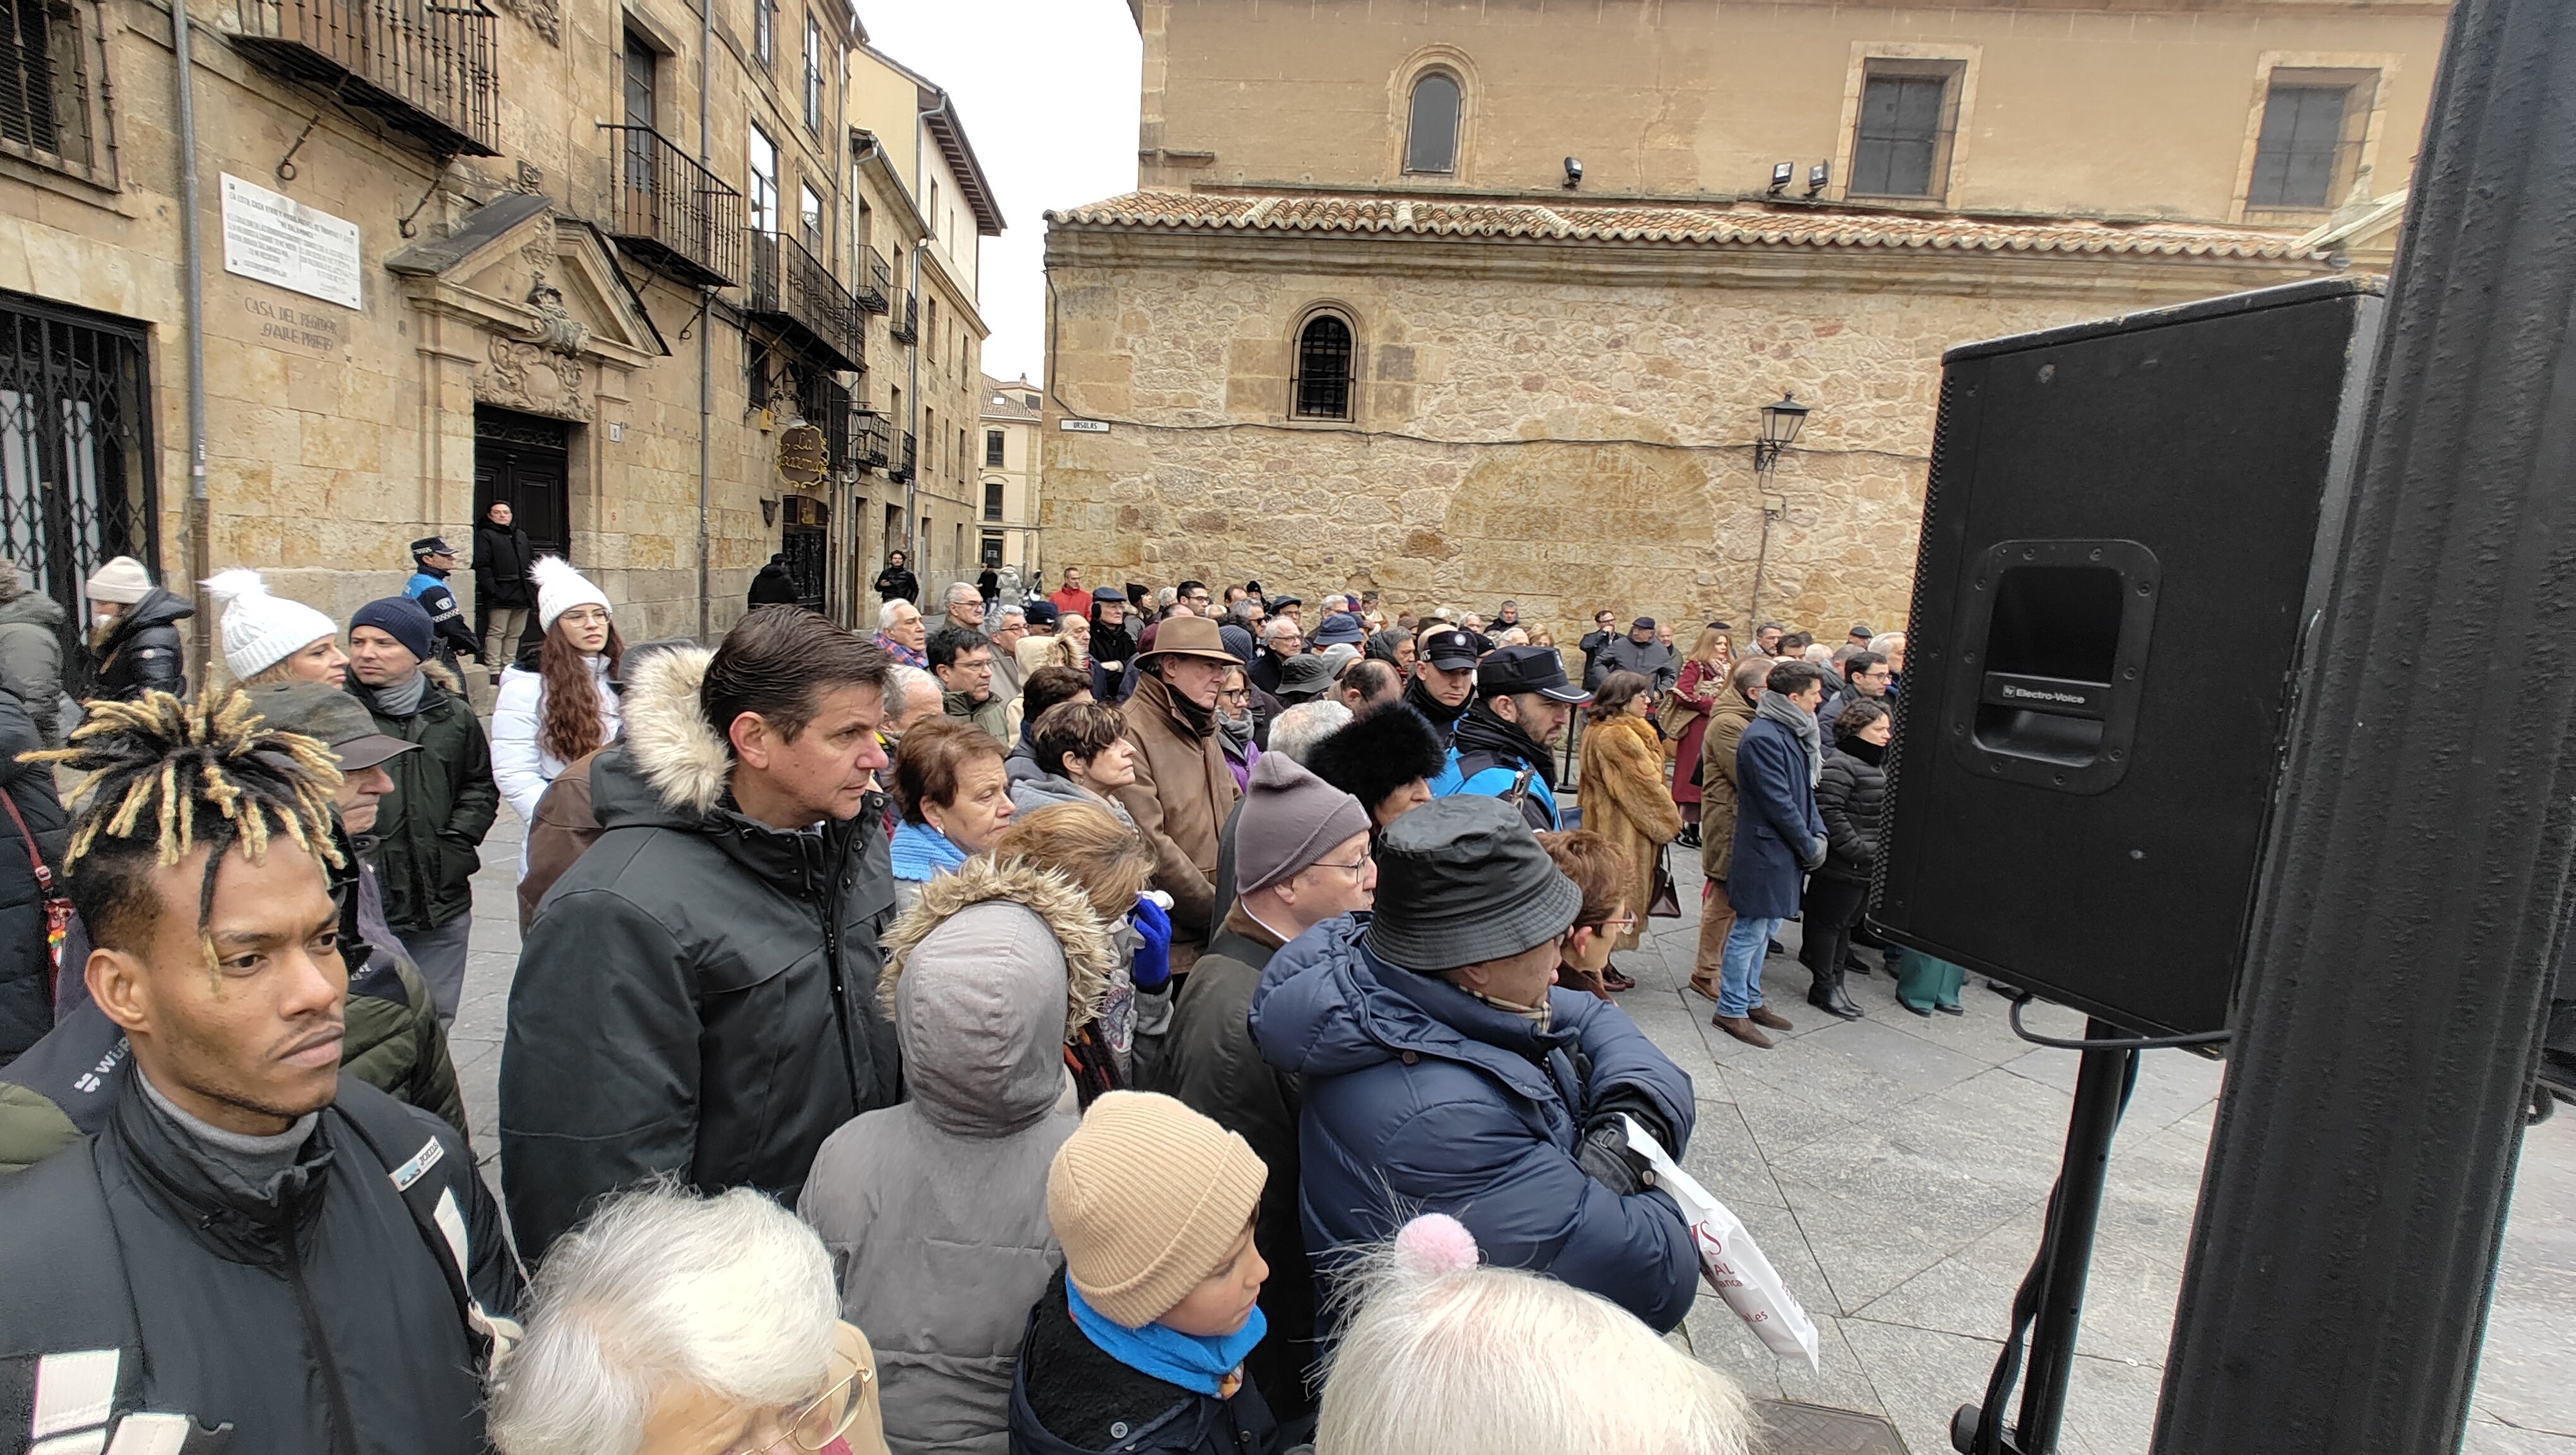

{"left": 26, "top": 688, "right": 343, "bottom": 958}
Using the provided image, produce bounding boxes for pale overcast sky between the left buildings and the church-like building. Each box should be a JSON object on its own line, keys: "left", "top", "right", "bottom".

{"left": 858, "top": 0, "right": 1141, "bottom": 381}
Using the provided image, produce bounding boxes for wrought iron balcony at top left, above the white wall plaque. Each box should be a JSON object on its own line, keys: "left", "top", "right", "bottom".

{"left": 234, "top": 0, "right": 500, "bottom": 157}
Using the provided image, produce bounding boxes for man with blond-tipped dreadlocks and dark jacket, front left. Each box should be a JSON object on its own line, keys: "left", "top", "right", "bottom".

{"left": 0, "top": 693, "right": 520, "bottom": 1455}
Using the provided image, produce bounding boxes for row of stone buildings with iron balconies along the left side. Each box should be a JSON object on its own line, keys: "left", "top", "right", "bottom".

{"left": 0, "top": 0, "right": 1002, "bottom": 680}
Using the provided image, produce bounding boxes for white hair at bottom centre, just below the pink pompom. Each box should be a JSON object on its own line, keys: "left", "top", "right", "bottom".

{"left": 1314, "top": 1236, "right": 1754, "bottom": 1455}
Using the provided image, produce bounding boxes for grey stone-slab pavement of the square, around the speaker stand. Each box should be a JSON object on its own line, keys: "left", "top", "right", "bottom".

{"left": 451, "top": 811, "right": 2576, "bottom": 1455}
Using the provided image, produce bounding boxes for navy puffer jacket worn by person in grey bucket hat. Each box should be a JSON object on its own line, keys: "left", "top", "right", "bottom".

{"left": 1252, "top": 919, "right": 1700, "bottom": 1331}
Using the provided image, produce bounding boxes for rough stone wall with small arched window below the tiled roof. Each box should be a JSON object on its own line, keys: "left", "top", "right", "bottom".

{"left": 1043, "top": 224, "right": 2349, "bottom": 641}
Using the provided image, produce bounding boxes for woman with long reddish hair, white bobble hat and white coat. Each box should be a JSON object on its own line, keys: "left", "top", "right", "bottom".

{"left": 492, "top": 556, "right": 626, "bottom": 860}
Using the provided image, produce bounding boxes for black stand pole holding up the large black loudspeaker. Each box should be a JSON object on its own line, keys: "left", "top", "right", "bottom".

{"left": 1950, "top": 1020, "right": 2138, "bottom": 1455}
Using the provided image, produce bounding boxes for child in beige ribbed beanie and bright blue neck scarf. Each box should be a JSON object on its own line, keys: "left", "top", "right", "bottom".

{"left": 1010, "top": 1092, "right": 1278, "bottom": 1455}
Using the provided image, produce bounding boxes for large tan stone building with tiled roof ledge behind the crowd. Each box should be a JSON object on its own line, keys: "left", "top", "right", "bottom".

{"left": 1043, "top": 0, "right": 2445, "bottom": 636}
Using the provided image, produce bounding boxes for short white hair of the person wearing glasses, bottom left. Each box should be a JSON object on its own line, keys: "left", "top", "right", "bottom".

{"left": 489, "top": 1185, "right": 840, "bottom": 1455}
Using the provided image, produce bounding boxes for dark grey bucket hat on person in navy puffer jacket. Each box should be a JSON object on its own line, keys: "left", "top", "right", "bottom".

{"left": 1368, "top": 793, "right": 1584, "bottom": 976}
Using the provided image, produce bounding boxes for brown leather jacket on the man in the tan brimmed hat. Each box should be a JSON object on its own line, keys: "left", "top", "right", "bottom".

{"left": 1118, "top": 674, "right": 1236, "bottom": 952}
